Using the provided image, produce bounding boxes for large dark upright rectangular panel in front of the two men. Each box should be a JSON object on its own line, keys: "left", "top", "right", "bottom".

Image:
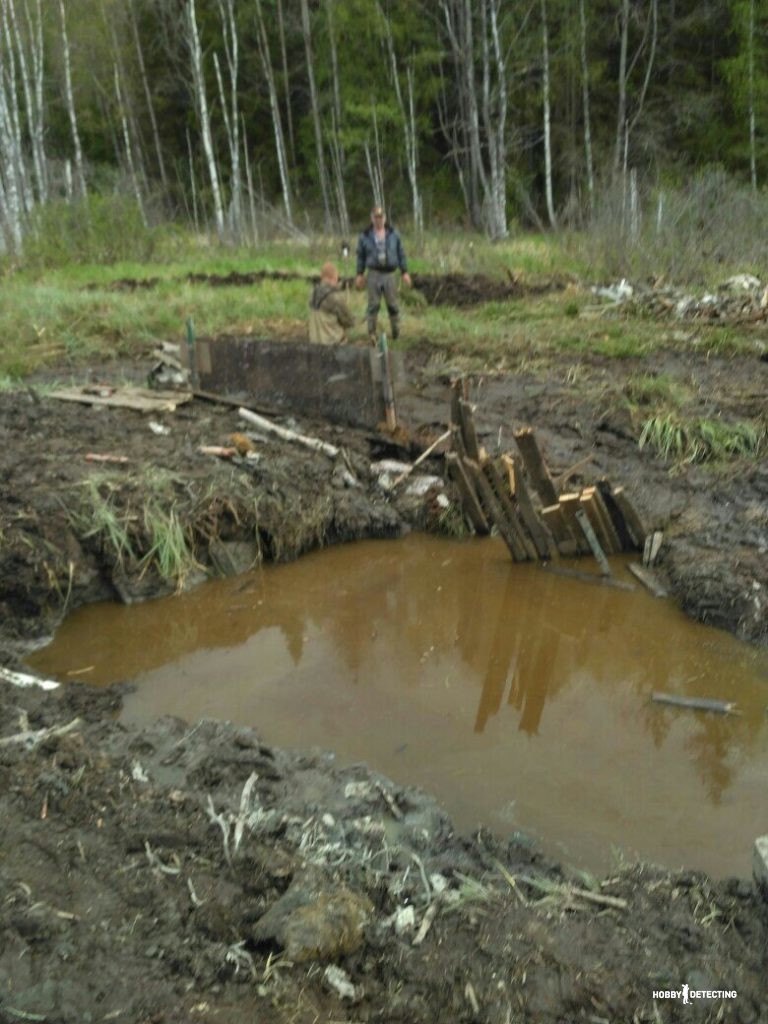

{"left": 195, "top": 337, "right": 404, "bottom": 427}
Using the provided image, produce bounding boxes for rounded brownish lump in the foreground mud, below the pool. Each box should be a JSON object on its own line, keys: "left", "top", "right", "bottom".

{"left": 253, "top": 871, "right": 373, "bottom": 964}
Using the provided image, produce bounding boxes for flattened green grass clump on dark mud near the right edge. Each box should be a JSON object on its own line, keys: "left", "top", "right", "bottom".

{"left": 639, "top": 412, "right": 765, "bottom": 464}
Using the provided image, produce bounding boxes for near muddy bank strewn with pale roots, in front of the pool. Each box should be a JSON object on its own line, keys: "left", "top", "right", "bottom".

{"left": 0, "top": 685, "right": 768, "bottom": 1024}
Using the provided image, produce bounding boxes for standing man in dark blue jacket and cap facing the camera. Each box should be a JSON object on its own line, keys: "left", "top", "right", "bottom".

{"left": 355, "top": 206, "right": 411, "bottom": 345}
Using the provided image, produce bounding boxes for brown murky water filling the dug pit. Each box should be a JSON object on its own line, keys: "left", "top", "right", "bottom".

{"left": 31, "top": 537, "right": 768, "bottom": 876}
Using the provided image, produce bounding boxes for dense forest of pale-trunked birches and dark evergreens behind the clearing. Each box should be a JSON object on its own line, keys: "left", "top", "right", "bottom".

{"left": 0, "top": 0, "right": 768, "bottom": 253}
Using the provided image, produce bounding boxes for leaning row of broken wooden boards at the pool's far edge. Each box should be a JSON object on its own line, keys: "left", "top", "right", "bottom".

{"left": 445, "top": 381, "right": 647, "bottom": 574}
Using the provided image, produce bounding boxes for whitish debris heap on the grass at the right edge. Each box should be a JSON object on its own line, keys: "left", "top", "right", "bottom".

{"left": 592, "top": 273, "right": 768, "bottom": 324}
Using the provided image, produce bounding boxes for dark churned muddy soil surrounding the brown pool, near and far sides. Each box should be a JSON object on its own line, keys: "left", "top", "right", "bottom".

{"left": 0, "top": 346, "right": 768, "bottom": 1024}
